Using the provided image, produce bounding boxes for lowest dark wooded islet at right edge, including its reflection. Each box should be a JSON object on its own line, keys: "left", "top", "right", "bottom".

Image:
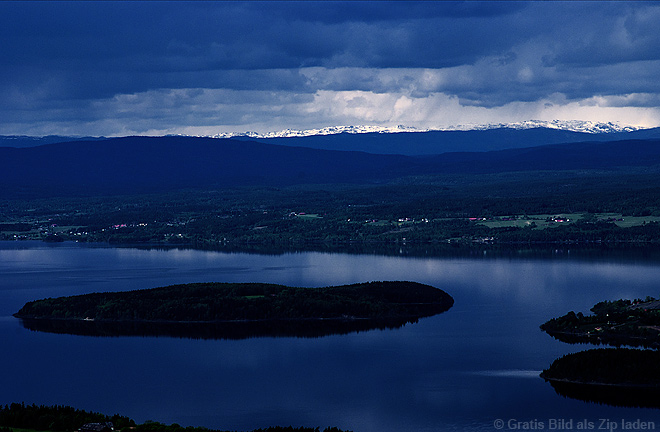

{"left": 541, "top": 348, "right": 660, "bottom": 408}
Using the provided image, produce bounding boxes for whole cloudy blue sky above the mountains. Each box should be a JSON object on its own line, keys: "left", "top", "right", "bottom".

{"left": 0, "top": 1, "right": 660, "bottom": 136}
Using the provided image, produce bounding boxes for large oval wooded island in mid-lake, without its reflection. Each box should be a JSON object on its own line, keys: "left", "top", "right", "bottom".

{"left": 16, "top": 282, "right": 453, "bottom": 322}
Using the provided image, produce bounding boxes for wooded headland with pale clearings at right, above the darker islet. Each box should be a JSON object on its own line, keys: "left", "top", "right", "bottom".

{"left": 541, "top": 297, "right": 660, "bottom": 348}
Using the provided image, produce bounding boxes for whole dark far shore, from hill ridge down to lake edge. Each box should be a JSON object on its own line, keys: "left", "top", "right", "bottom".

{"left": 0, "top": 137, "right": 660, "bottom": 249}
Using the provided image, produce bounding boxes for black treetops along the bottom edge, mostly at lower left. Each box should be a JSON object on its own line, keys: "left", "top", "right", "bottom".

{"left": 0, "top": 403, "right": 349, "bottom": 432}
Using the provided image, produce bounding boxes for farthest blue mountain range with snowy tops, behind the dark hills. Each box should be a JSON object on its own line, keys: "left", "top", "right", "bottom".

{"left": 0, "top": 120, "right": 660, "bottom": 156}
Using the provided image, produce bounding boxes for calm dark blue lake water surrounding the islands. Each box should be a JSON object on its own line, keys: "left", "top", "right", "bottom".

{"left": 0, "top": 242, "right": 660, "bottom": 432}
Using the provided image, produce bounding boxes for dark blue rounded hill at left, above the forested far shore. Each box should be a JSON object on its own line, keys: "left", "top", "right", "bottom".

{"left": 0, "top": 137, "right": 418, "bottom": 194}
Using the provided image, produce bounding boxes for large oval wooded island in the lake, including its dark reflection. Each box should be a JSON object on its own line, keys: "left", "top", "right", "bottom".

{"left": 14, "top": 282, "right": 454, "bottom": 339}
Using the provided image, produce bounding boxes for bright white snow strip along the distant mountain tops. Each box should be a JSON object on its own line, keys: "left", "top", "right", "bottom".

{"left": 213, "top": 120, "right": 642, "bottom": 138}
